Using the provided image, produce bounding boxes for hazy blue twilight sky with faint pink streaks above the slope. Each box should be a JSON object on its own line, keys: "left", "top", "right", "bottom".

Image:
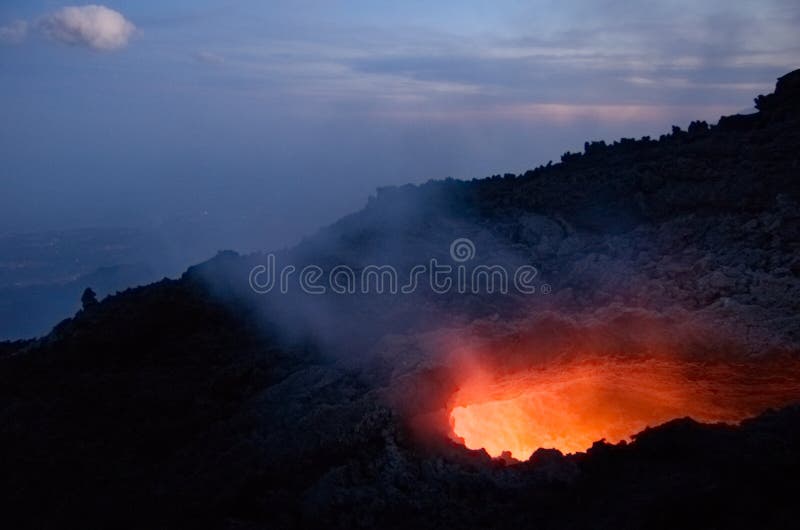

{"left": 0, "top": 0, "right": 800, "bottom": 249}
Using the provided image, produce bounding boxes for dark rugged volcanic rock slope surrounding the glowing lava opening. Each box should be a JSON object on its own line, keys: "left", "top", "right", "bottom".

{"left": 0, "top": 71, "right": 800, "bottom": 528}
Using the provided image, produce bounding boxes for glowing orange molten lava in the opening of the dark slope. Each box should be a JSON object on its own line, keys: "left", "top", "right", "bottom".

{"left": 450, "top": 358, "right": 800, "bottom": 460}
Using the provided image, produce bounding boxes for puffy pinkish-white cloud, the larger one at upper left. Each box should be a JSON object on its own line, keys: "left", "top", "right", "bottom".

{"left": 38, "top": 5, "right": 136, "bottom": 51}
